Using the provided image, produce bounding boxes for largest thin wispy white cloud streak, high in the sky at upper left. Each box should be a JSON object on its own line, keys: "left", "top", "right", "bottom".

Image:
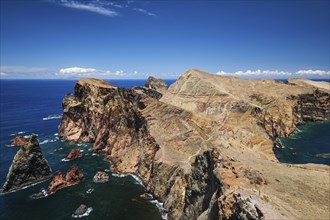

{"left": 59, "top": 0, "right": 119, "bottom": 17}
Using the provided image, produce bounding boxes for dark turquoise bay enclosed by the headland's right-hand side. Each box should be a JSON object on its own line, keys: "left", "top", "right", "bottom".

{"left": 275, "top": 121, "right": 330, "bottom": 165}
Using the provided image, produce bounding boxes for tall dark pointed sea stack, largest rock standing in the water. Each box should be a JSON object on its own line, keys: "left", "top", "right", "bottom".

{"left": 2, "top": 134, "right": 52, "bottom": 193}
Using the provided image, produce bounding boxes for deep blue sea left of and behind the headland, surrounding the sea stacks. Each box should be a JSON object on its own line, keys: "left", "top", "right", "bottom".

{"left": 0, "top": 80, "right": 174, "bottom": 220}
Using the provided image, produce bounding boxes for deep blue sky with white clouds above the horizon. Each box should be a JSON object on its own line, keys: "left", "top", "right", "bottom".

{"left": 0, "top": 0, "right": 330, "bottom": 78}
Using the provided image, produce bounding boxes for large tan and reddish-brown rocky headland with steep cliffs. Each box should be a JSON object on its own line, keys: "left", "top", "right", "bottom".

{"left": 59, "top": 70, "right": 330, "bottom": 219}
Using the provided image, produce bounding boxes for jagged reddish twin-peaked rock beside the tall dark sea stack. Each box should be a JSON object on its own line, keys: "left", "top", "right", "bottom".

{"left": 47, "top": 165, "right": 84, "bottom": 193}
